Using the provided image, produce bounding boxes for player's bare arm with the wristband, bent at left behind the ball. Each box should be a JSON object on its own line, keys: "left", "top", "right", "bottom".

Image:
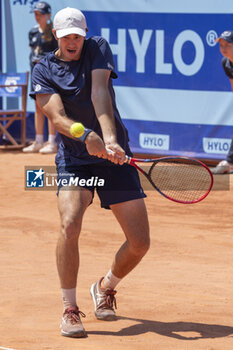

{"left": 36, "top": 94, "right": 107, "bottom": 158}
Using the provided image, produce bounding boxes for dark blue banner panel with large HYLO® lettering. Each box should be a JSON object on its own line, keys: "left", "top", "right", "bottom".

{"left": 86, "top": 12, "right": 233, "bottom": 91}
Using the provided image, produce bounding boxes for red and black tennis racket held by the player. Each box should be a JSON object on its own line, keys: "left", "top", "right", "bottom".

{"left": 125, "top": 156, "right": 213, "bottom": 204}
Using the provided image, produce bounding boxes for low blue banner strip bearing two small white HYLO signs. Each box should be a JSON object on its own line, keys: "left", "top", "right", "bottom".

{"left": 125, "top": 120, "right": 233, "bottom": 159}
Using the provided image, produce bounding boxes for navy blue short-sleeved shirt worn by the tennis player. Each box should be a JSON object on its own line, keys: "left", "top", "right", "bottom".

{"left": 30, "top": 37, "right": 131, "bottom": 164}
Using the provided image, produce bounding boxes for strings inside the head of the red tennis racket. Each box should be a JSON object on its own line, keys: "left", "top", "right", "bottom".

{"left": 149, "top": 160, "right": 211, "bottom": 202}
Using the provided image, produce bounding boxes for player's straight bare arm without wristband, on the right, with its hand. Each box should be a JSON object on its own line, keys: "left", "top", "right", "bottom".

{"left": 91, "top": 69, "right": 125, "bottom": 164}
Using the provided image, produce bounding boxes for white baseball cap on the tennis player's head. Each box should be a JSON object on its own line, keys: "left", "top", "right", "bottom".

{"left": 53, "top": 7, "right": 87, "bottom": 39}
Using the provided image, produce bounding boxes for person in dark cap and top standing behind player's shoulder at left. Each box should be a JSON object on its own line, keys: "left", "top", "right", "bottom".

{"left": 23, "top": 1, "right": 57, "bottom": 154}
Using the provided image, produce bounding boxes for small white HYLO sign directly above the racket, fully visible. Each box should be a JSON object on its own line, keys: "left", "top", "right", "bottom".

{"left": 139, "top": 133, "right": 170, "bottom": 151}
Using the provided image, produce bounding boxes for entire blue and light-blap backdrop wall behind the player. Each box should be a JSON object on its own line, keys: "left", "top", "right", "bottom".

{"left": 2, "top": 0, "right": 233, "bottom": 159}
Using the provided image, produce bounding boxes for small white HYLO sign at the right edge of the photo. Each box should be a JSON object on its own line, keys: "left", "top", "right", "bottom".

{"left": 203, "top": 137, "right": 231, "bottom": 154}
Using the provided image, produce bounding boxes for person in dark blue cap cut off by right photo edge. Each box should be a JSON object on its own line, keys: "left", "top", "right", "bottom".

{"left": 212, "top": 30, "right": 233, "bottom": 174}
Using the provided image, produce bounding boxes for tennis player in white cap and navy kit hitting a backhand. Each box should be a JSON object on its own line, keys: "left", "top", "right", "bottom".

{"left": 31, "top": 8, "right": 149, "bottom": 337}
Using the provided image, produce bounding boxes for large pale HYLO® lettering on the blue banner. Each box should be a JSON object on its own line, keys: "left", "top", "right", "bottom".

{"left": 101, "top": 28, "right": 210, "bottom": 76}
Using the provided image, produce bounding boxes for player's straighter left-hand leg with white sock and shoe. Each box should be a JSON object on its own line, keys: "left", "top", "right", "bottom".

{"left": 56, "top": 189, "right": 92, "bottom": 337}
